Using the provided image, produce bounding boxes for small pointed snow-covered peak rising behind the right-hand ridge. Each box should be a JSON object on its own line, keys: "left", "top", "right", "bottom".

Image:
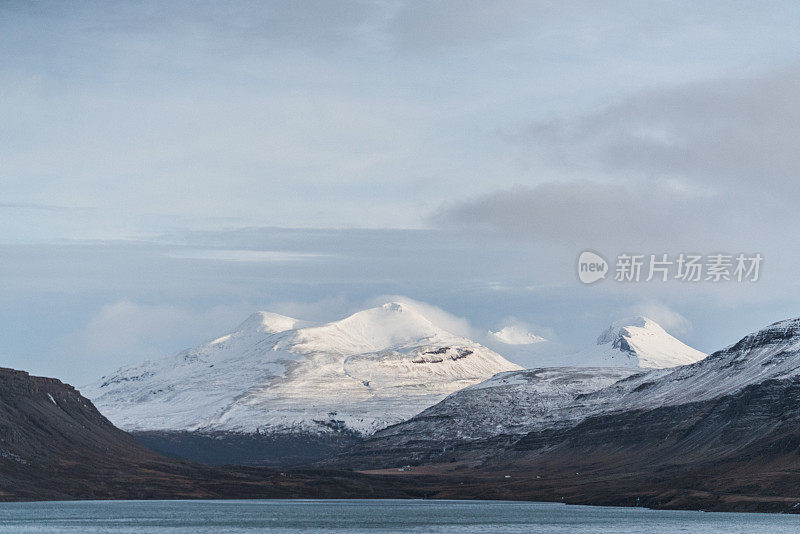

{"left": 567, "top": 317, "right": 706, "bottom": 369}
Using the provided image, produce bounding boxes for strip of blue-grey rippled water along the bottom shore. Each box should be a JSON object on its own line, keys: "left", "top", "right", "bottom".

{"left": 0, "top": 500, "right": 800, "bottom": 534}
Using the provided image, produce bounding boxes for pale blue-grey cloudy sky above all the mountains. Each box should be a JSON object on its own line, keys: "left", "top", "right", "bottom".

{"left": 0, "top": 0, "right": 800, "bottom": 386}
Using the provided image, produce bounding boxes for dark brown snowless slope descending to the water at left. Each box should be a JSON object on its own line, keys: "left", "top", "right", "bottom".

{"left": 0, "top": 368, "right": 450, "bottom": 502}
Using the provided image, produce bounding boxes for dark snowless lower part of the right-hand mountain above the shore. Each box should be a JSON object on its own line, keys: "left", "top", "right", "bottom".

{"left": 400, "top": 377, "right": 800, "bottom": 516}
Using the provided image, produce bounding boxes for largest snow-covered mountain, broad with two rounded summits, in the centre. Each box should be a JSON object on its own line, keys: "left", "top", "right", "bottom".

{"left": 82, "top": 303, "right": 520, "bottom": 434}
